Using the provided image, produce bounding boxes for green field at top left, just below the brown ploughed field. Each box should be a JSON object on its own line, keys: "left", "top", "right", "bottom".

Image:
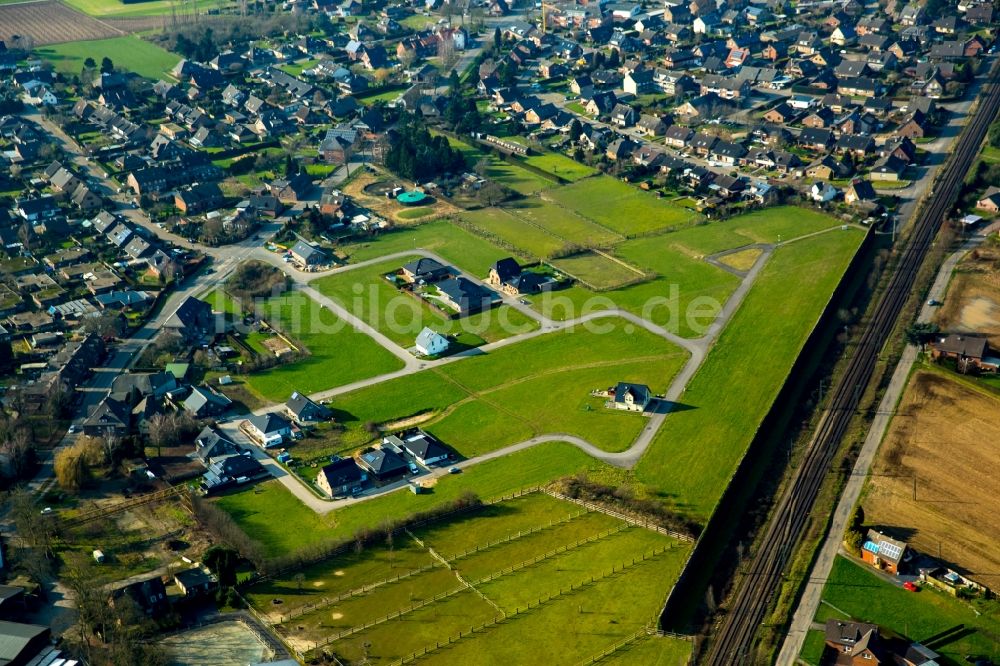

{"left": 35, "top": 37, "right": 181, "bottom": 80}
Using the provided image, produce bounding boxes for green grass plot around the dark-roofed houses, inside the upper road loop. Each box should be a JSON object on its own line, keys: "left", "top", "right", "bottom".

{"left": 313, "top": 256, "right": 538, "bottom": 348}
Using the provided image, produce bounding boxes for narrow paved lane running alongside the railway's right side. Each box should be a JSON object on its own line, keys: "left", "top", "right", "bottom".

{"left": 776, "top": 230, "right": 984, "bottom": 666}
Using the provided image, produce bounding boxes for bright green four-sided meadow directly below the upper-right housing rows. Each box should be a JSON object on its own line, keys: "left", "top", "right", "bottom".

{"left": 544, "top": 176, "right": 701, "bottom": 236}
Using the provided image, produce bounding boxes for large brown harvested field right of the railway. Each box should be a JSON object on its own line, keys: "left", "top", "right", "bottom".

{"left": 862, "top": 370, "right": 1000, "bottom": 588}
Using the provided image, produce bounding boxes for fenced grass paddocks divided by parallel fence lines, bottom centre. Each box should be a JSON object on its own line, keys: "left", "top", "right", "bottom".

{"left": 249, "top": 493, "right": 690, "bottom": 664}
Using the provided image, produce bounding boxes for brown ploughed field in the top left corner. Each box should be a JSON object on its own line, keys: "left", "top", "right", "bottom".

{"left": 0, "top": 0, "right": 124, "bottom": 46}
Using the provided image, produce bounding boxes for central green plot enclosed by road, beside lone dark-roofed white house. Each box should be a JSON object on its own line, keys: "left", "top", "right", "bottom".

{"left": 328, "top": 320, "right": 687, "bottom": 457}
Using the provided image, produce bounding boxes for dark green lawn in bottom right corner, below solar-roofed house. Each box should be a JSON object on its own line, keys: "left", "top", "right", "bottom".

{"left": 814, "top": 556, "right": 1000, "bottom": 664}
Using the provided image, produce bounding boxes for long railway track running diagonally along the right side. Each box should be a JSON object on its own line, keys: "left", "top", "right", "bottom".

{"left": 704, "top": 63, "right": 1000, "bottom": 666}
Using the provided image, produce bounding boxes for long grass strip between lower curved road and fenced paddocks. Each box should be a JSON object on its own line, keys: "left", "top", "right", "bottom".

{"left": 220, "top": 442, "right": 611, "bottom": 557}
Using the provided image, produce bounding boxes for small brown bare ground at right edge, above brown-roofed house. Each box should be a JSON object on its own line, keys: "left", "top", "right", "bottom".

{"left": 937, "top": 248, "right": 1000, "bottom": 347}
